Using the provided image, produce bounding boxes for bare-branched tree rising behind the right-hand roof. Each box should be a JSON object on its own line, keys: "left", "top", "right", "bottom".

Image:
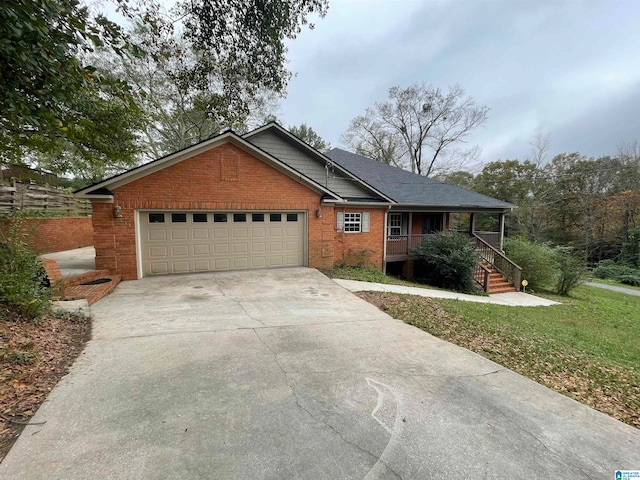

{"left": 341, "top": 83, "right": 489, "bottom": 176}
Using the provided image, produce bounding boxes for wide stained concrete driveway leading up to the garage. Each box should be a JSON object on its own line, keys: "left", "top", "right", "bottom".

{"left": 0, "top": 268, "right": 640, "bottom": 480}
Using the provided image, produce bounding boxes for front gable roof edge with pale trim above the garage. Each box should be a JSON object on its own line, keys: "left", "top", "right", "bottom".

{"left": 75, "top": 130, "right": 340, "bottom": 201}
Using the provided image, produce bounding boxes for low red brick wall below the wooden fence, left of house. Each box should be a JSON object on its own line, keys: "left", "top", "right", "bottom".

{"left": 0, "top": 217, "right": 93, "bottom": 253}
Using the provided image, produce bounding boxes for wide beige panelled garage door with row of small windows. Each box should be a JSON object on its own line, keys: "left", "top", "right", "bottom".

{"left": 139, "top": 210, "right": 305, "bottom": 276}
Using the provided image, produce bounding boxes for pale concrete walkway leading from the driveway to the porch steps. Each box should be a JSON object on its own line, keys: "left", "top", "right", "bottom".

{"left": 333, "top": 278, "right": 559, "bottom": 307}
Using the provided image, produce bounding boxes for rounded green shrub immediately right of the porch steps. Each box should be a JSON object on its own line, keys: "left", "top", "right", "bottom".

{"left": 504, "top": 238, "right": 558, "bottom": 290}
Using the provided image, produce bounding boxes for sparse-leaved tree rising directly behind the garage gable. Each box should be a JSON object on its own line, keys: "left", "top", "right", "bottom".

{"left": 95, "top": 20, "right": 277, "bottom": 159}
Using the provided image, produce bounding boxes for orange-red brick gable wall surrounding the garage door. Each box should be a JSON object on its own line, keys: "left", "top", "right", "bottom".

{"left": 93, "top": 144, "right": 344, "bottom": 280}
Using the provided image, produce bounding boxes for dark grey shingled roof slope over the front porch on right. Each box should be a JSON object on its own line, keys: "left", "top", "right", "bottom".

{"left": 325, "top": 148, "right": 514, "bottom": 210}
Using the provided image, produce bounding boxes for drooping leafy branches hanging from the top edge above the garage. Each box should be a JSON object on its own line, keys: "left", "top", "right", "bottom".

{"left": 120, "top": 0, "right": 328, "bottom": 140}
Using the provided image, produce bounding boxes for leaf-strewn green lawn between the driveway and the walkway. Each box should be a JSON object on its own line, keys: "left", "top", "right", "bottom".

{"left": 361, "top": 286, "right": 640, "bottom": 427}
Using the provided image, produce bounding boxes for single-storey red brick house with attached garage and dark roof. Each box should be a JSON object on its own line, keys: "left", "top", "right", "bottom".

{"left": 76, "top": 122, "right": 513, "bottom": 290}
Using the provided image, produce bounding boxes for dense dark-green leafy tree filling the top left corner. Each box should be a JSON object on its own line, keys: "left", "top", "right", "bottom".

{"left": 0, "top": 0, "right": 138, "bottom": 176}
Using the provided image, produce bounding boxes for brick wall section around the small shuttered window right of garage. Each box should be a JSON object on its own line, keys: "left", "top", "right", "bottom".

{"left": 333, "top": 206, "right": 386, "bottom": 269}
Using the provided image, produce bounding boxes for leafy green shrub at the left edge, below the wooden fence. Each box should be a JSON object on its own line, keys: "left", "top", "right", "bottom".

{"left": 0, "top": 224, "right": 51, "bottom": 319}
